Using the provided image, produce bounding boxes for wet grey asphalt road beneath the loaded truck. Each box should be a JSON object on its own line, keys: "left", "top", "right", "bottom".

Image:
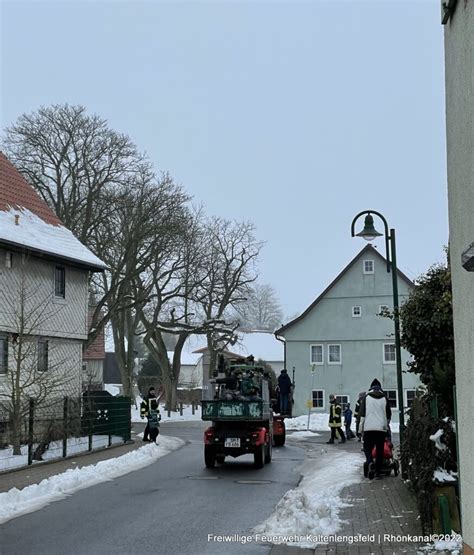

{"left": 0, "top": 422, "right": 305, "bottom": 555}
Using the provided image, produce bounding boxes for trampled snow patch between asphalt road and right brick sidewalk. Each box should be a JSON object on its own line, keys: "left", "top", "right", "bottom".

{"left": 254, "top": 451, "right": 363, "bottom": 547}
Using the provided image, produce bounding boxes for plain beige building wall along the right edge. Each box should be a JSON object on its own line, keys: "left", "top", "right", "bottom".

{"left": 443, "top": 2, "right": 474, "bottom": 555}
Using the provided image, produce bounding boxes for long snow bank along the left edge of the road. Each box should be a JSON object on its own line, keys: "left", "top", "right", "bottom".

{"left": 0, "top": 436, "right": 185, "bottom": 524}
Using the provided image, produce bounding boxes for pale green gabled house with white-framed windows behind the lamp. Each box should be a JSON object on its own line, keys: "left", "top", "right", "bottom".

{"left": 275, "top": 245, "right": 420, "bottom": 421}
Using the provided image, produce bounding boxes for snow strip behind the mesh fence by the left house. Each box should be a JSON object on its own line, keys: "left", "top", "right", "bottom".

{"left": 0, "top": 435, "right": 123, "bottom": 472}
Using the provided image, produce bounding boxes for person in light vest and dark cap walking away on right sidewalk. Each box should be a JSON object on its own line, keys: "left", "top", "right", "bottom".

{"left": 359, "top": 379, "right": 392, "bottom": 478}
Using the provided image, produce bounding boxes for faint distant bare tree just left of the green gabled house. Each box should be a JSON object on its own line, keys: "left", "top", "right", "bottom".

{"left": 236, "top": 283, "right": 283, "bottom": 331}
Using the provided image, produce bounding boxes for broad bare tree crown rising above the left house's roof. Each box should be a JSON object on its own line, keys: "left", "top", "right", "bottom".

{"left": 3, "top": 104, "right": 147, "bottom": 245}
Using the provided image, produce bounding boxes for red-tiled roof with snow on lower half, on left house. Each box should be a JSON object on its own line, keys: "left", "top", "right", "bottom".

{"left": 0, "top": 152, "right": 105, "bottom": 271}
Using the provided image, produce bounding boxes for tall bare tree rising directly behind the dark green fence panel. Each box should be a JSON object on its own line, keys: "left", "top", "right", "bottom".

{"left": 90, "top": 173, "right": 187, "bottom": 396}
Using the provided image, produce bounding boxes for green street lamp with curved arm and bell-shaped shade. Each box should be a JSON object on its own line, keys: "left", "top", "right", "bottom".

{"left": 351, "top": 210, "right": 405, "bottom": 448}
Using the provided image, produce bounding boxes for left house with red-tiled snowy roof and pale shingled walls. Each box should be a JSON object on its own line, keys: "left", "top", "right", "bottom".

{"left": 0, "top": 153, "right": 104, "bottom": 400}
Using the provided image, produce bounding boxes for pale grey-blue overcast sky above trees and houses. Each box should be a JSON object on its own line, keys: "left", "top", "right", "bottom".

{"left": 1, "top": 0, "right": 448, "bottom": 317}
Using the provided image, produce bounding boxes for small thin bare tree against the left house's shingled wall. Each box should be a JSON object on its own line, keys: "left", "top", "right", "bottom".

{"left": 0, "top": 271, "right": 80, "bottom": 455}
